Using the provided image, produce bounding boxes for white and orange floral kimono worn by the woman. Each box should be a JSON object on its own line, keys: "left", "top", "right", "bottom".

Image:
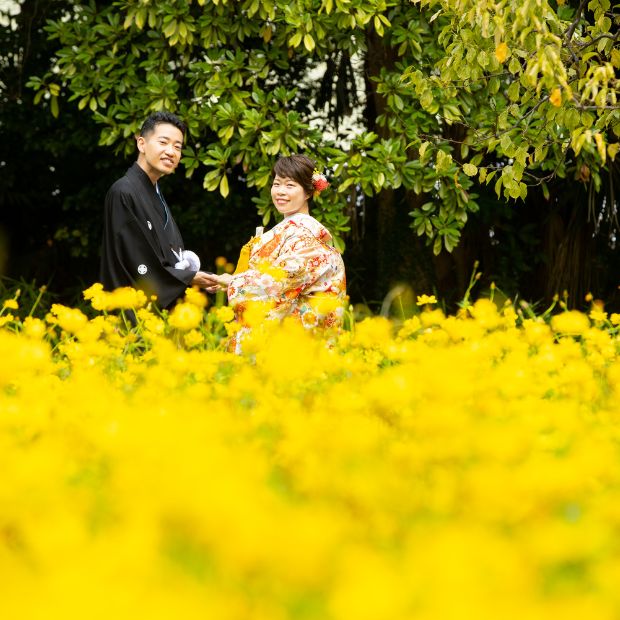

{"left": 228, "top": 213, "right": 346, "bottom": 328}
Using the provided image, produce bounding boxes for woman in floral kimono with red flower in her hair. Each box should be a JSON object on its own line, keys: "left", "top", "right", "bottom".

{"left": 207, "top": 155, "right": 346, "bottom": 340}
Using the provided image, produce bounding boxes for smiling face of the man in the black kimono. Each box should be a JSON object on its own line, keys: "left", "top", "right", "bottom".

{"left": 137, "top": 123, "right": 183, "bottom": 182}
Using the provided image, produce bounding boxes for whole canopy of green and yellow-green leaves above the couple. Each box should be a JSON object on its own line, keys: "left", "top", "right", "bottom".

{"left": 30, "top": 0, "right": 620, "bottom": 253}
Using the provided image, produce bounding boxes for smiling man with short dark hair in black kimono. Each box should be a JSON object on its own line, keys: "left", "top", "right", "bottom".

{"left": 101, "top": 112, "right": 210, "bottom": 308}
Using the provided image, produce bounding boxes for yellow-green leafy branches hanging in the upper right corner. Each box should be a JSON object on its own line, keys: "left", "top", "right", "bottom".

{"left": 405, "top": 0, "right": 620, "bottom": 199}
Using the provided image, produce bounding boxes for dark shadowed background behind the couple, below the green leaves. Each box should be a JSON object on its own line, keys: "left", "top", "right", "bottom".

{"left": 0, "top": 0, "right": 620, "bottom": 310}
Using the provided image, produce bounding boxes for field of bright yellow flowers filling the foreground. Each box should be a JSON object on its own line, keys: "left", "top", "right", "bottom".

{"left": 0, "top": 288, "right": 620, "bottom": 620}
